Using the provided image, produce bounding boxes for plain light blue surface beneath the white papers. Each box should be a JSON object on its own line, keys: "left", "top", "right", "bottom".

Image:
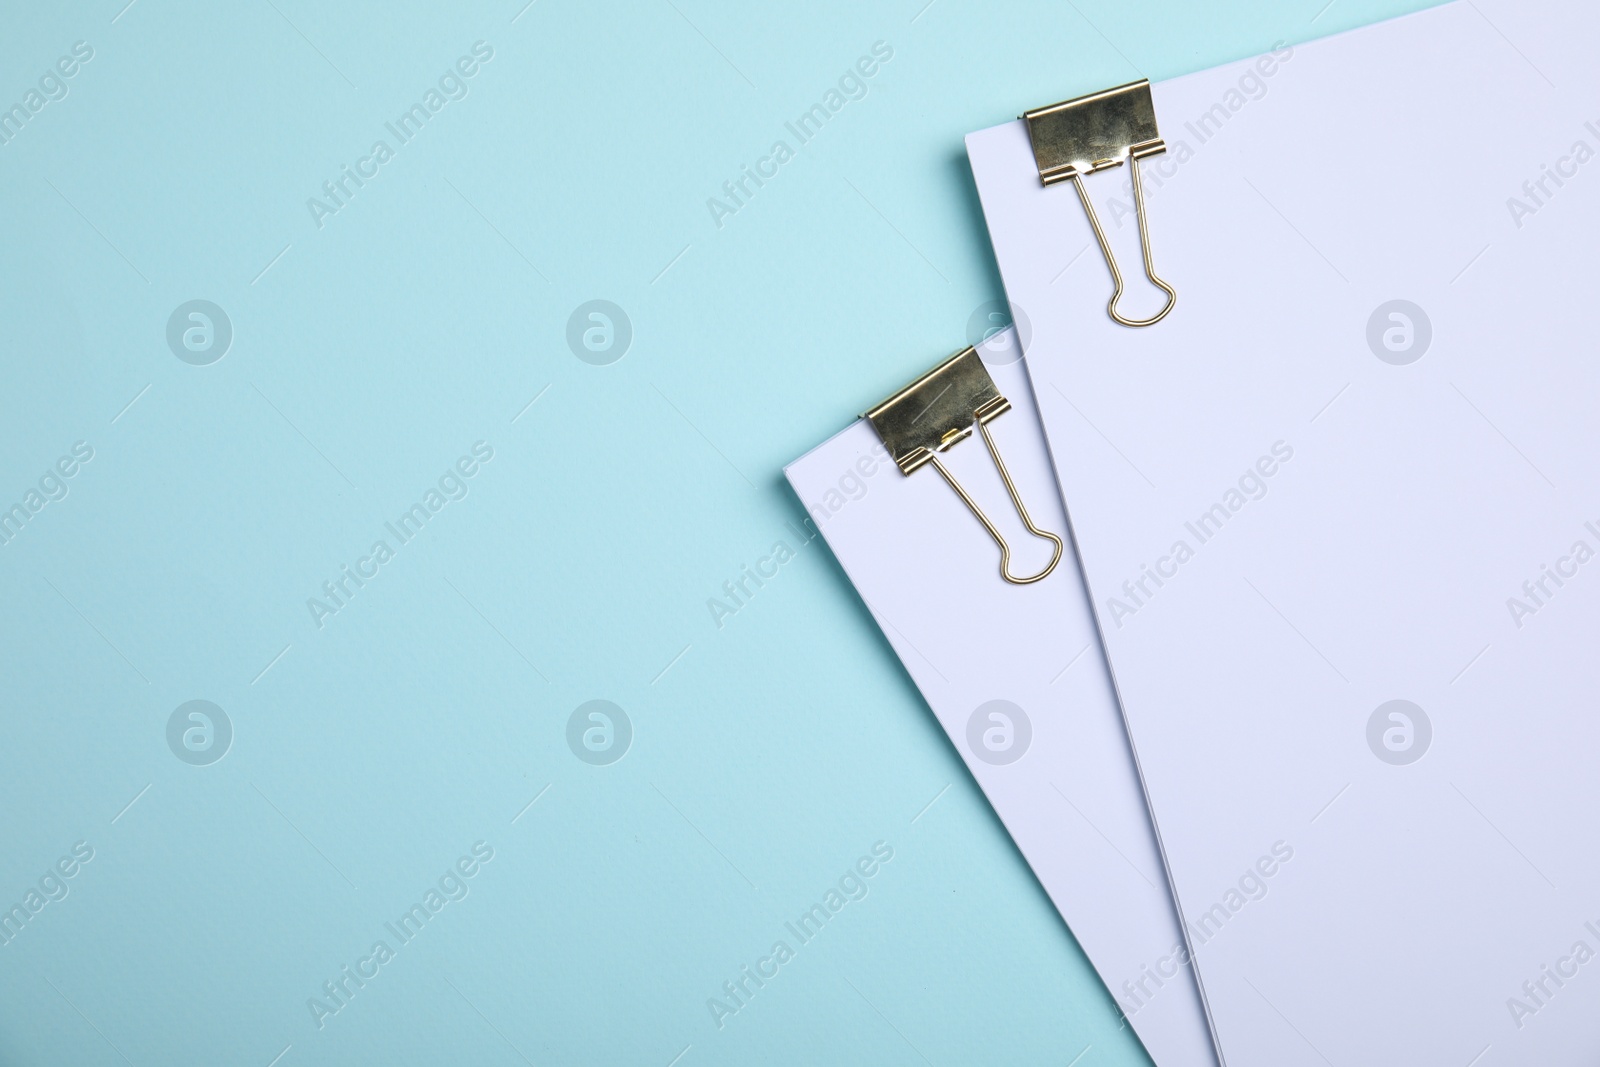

{"left": 0, "top": 0, "right": 1426, "bottom": 1067}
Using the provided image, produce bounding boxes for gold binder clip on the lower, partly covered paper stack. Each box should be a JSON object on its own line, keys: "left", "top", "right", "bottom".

{"left": 866, "top": 347, "right": 1066, "bottom": 585}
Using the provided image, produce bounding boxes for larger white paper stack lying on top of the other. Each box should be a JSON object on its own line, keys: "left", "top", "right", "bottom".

{"left": 968, "top": 0, "right": 1600, "bottom": 1067}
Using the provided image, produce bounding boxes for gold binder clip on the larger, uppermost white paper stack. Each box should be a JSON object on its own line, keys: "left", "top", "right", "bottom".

{"left": 1022, "top": 78, "right": 1178, "bottom": 326}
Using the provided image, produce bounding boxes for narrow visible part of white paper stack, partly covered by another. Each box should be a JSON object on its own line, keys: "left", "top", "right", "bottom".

{"left": 784, "top": 340, "right": 1216, "bottom": 1067}
